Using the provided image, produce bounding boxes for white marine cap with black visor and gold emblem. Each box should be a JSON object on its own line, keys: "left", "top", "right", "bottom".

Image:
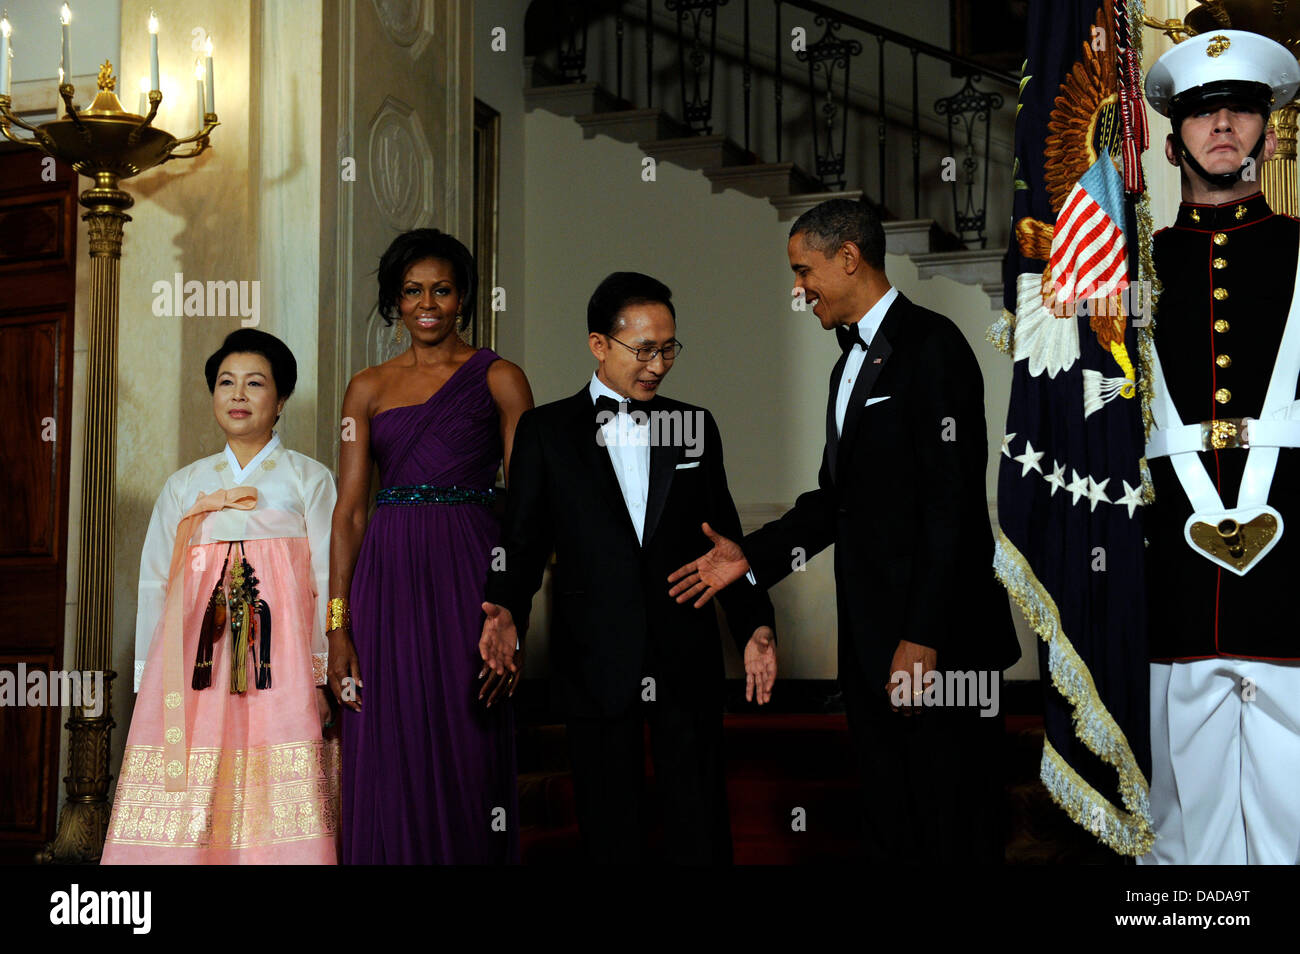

{"left": 1147, "top": 30, "right": 1300, "bottom": 118}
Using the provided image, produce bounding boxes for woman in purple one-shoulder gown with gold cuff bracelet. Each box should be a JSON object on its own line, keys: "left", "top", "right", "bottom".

{"left": 326, "top": 229, "right": 533, "bottom": 864}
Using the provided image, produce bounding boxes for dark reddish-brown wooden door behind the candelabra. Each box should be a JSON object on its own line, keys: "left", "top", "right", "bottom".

{"left": 0, "top": 146, "right": 77, "bottom": 864}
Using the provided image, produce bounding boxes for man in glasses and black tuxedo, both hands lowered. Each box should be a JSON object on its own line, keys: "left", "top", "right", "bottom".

{"left": 480, "top": 272, "right": 776, "bottom": 864}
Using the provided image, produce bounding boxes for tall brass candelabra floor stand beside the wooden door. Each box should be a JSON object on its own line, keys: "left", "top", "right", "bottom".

{"left": 0, "top": 61, "right": 220, "bottom": 863}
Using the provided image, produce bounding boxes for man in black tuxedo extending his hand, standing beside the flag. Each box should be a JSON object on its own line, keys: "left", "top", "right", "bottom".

{"left": 670, "top": 199, "right": 1019, "bottom": 864}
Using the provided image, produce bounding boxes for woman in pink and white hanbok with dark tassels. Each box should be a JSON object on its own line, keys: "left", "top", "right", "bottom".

{"left": 103, "top": 328, "right": 339, "bottom": 864}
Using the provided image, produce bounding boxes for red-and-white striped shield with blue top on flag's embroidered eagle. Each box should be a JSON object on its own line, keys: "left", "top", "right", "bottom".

{"left": 1049, "top": 153, "right": 1128, "bottom": 303}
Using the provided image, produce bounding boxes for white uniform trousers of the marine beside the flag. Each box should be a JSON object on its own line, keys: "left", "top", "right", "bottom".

{"left": 1138, "top": 659, "right": 1300, "bottom": 864}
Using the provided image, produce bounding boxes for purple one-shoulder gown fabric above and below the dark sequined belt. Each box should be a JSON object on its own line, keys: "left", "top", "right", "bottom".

{"left": 342, "top": 348, "right": 519, "bottom": 864}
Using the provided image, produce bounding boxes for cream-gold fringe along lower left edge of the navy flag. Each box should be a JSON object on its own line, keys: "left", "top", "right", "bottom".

{"left": 993, "top": 530, "right": 1156, "bottom": 857}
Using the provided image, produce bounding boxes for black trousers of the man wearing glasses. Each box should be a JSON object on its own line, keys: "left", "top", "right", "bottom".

{"left": 567, "top": 697, "right": 732, "bottom": 864}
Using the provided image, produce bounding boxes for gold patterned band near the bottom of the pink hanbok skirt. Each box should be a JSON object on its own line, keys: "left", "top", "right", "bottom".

{"left": 108, "top": 740, "right": 339, "bottom": 849}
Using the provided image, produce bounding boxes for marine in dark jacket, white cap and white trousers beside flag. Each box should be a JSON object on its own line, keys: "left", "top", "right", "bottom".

{"left": 1140, "top": 30, "right": 1300, "bottom": 864}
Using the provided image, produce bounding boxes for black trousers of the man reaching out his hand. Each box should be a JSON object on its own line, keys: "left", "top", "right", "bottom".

{"left": 840, "top": 658, "right": 1005, "bottom": 866}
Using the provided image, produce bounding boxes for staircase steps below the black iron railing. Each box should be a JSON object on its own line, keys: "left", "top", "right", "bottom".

{"left": 524, "top": 57, "right": 1006, "bottom": 309}
